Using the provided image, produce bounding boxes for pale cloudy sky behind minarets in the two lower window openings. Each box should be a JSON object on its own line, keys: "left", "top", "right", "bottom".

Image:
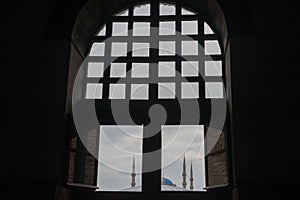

{"left": 97, "top": 126, "right": 205, "bottom": 191}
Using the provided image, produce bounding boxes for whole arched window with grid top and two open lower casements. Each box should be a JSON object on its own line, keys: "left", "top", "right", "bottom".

{"left": 65, "top": 1, "right": 230, "bottom": 198}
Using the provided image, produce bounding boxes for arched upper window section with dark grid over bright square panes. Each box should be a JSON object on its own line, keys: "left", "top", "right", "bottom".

{"left": 85, "top": 3, "right": 224, "bottom": 100}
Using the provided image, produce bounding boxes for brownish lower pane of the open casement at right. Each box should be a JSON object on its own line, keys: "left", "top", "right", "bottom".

{"left": 207, "top": 152, "right": 228, "bottom": 186}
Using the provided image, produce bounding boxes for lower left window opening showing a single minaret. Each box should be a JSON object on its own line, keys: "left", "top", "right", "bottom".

{"left": 97, "top": 126, "right": 143, "bottom": 192}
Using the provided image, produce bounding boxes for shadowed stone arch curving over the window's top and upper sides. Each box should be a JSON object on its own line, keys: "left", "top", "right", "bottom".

{"left": 67, "top": 0, "right": 236, "bottom": 197}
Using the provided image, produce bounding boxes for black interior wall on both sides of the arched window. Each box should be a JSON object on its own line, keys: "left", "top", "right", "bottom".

{"left": 0, "top": 0, "right": 300, "bottom": 200}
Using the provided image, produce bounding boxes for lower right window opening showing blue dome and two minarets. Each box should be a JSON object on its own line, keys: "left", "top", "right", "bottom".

{"left": 161, "top": 125, "right": 206, "bottom": 191}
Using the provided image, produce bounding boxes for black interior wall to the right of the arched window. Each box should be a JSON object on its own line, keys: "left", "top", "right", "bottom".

{"left": 227, "top": 1, "right": 300, "bottom": 199}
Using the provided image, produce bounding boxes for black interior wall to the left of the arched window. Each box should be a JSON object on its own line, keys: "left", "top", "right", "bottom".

{"left": 0, "top": 1, "right": 74, "bottom": 199}
